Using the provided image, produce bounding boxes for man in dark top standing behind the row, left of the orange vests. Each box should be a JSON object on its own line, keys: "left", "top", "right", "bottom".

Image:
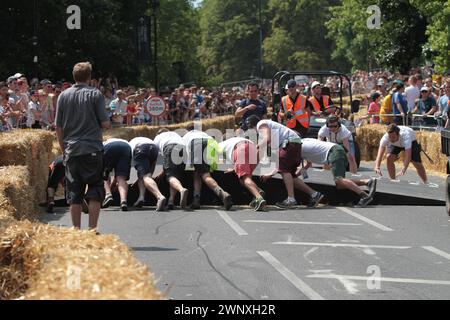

{"left": 235, "top": 82, "right": 267, "bottom": 131}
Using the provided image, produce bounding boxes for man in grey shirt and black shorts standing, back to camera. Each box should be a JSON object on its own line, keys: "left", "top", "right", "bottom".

{"left": 56, "top": 62, "right": 111, "bottom": 230}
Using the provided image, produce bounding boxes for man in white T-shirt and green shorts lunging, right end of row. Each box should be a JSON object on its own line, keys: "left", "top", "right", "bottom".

{"left": 297, "top": 139, "right": 377, "bottom": 208}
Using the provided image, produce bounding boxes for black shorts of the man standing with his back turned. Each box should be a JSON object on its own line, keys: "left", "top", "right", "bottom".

{"left": 66, "top": 151, "right": 105, "bottom": 205}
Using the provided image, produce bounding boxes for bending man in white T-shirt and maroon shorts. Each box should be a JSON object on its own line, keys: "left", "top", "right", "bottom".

{"left": 247, "top": 116, "right": 323, "bottom": 209}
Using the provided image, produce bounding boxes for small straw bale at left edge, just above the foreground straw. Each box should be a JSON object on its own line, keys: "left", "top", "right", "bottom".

{"left": 0, "top": 166, "right": 37, "bottom": 220}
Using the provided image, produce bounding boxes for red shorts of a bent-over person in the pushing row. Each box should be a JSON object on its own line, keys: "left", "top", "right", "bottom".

{"left": 233, "top": 142, "right": 258, "bottom": 179}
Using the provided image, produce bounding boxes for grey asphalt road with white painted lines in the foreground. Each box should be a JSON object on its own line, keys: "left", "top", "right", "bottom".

{"left": 43, "top": 202, "right": 450, "bottom": 300}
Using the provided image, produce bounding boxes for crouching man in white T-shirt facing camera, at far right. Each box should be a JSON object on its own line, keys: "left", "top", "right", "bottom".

{"left": 375, "top": 124, "right": 428, "bottom": 184}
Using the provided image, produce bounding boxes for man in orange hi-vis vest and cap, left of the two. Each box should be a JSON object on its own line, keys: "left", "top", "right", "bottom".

{"left": 278, "top": 80, "right": 313, "bottom": 137}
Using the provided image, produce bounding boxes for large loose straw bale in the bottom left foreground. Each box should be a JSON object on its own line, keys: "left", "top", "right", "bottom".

{"left": 0, "top": 222, "right": 164, "bottom": 300}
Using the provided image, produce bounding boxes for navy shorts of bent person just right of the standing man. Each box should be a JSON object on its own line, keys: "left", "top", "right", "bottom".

{"left": 103, "top": 141, "right": 131, "bottom": 181}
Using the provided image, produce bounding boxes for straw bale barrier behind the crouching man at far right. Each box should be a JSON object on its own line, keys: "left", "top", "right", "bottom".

{"left": 357, "top": 124, "right": 447, "bottom": 174}
